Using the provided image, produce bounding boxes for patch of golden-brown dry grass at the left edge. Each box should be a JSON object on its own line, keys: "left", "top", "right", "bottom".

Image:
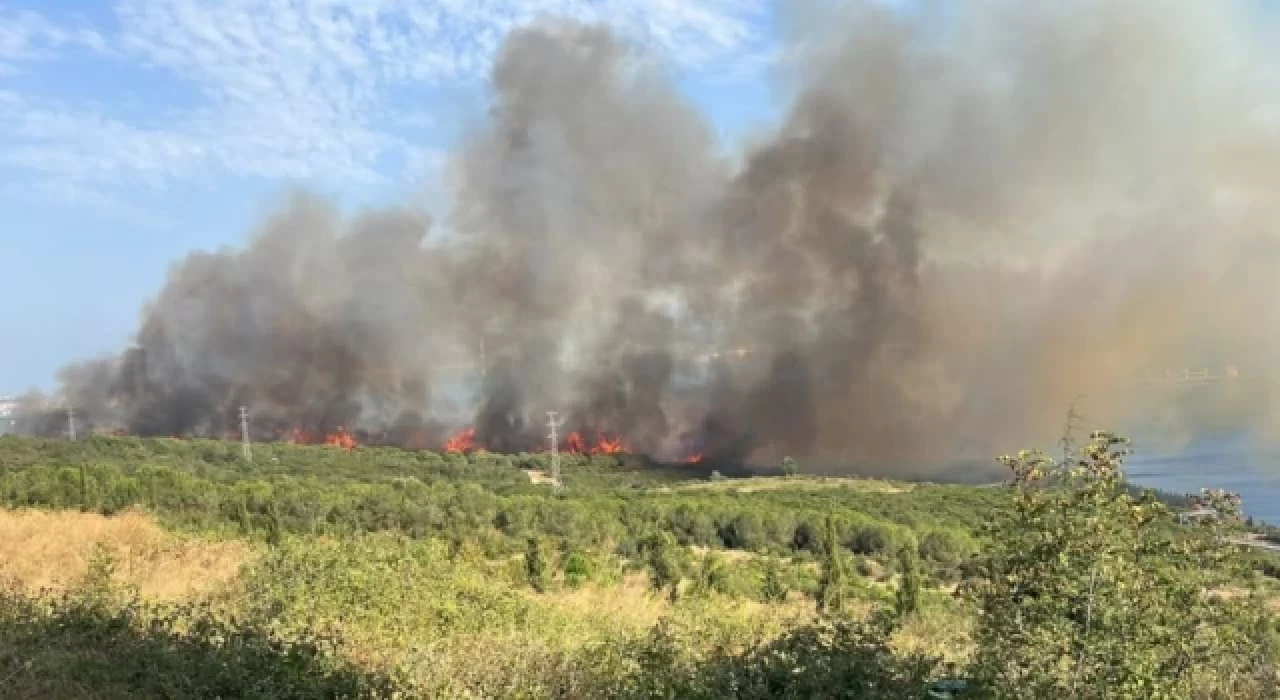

{"left": 0, "top": 509, "right": 252, "bottom": 600}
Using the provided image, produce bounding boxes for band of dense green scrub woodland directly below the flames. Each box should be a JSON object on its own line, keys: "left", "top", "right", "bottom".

{"left": 0, "top": 436, "right": 1002, "bottom": 563}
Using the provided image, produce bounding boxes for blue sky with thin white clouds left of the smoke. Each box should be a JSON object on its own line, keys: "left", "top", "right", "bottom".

{"left": 0, "top": 0, "right": 808, "bottom": 394}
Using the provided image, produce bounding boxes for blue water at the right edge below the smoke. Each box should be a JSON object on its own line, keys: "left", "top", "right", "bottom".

{"left": 1126, "top": 436, "right": 1280, "bottom": 525}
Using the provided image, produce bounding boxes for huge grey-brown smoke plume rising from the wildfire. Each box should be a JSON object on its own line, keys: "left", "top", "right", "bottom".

{"left": 24, "top": 0, "right": 1280, "bottom": 473}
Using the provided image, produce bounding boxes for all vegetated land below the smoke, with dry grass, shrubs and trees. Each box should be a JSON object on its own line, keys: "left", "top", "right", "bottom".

{"left": 0, "top": 433, "right": 1280, "bottom": 699}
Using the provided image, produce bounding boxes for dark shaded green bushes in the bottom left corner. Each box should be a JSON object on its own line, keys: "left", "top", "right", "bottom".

{"left": 0, "top": 590, "right": 406, "bottom": 700}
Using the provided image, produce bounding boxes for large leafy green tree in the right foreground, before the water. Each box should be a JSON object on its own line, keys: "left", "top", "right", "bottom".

{"left": 963, "top": 433, "right": 1270, "bottom": 699}
